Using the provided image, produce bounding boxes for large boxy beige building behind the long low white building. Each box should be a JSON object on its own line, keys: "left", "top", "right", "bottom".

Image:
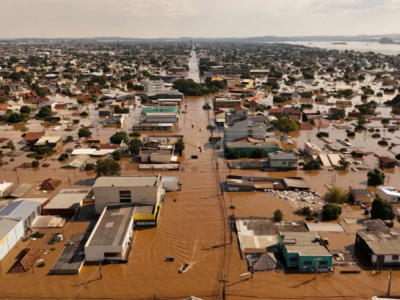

{"left": 93, "top": 175, "right": 164, "bottom": 214}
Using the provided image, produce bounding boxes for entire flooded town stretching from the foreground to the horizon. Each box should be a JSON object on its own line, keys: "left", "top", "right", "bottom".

{"left": 0, "top": 40, "right": 400, "bottom": 300}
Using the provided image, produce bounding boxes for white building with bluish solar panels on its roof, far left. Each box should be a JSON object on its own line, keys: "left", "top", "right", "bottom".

{"left": 0, "top": 200, "right": 42, "bottom": 232}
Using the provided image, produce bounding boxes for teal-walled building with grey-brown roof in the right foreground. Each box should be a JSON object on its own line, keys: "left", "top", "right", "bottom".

{"left": 278, "top": 232, "right": 333, "bottom": 271}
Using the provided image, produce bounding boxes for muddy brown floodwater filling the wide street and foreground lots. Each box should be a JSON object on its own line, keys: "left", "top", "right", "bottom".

{"left": 0, "top": 79, "right": 400, "bottom": 299}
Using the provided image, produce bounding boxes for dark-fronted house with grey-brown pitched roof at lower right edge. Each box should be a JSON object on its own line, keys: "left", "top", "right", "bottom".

{"left": 355, "top": 219, "right": 400, "bottom": 267}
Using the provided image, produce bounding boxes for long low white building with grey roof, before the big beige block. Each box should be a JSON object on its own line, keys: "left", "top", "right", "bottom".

{"left": 85, "top": 204, "right": 135, "bottom": 261}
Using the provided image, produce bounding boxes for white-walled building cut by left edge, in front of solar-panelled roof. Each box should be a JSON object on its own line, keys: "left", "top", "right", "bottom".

{"left": 0, "top": 216, "right": 25, "bottom": 261}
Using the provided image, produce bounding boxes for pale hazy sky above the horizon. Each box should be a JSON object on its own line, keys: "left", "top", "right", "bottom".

{"left": 0, "top": 0, "right": 400, "bottom": 38}
